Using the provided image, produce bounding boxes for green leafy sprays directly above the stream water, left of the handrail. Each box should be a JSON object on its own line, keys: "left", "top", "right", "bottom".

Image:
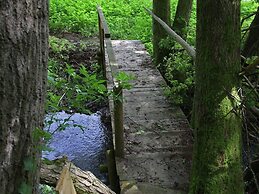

{"left": 47, "top": 60, "right": 106, "bottom": 113}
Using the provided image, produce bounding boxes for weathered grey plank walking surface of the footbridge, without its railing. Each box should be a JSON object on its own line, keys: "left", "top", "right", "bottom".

{"left": 107, "top": 40, "right": 192, "bottom": 194}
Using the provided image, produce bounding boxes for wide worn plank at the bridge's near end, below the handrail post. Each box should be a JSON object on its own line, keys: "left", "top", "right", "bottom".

{"left": 116, "top": 152, "right": 191, "bottom": 188}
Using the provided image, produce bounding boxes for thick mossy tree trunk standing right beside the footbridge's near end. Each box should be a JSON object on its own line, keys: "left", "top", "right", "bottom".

{"left": 190, "top": 0, "right": 244, "bottom": 194}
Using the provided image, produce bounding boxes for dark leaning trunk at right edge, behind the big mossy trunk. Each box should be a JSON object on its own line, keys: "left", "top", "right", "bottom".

{"left": 242, "top": 7, "right": 259, "bottom": 57}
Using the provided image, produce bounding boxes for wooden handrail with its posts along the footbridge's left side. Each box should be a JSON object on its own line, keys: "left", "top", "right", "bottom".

{"left": 97, "top": 5, "right": 124, "bottom": 157}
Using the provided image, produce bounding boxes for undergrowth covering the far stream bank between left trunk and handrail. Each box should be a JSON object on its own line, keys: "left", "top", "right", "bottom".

{"left": 46, "top": 37, "right": 107, "bottom": 113}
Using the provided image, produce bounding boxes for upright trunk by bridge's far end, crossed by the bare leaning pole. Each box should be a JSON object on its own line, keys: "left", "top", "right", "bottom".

{"left": 153, "top": 0, "right": 171, "bottom": 74}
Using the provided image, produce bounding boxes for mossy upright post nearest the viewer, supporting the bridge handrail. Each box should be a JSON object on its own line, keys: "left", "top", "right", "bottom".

{"left": 113, "top": 86, "right": 124, "bottom": 157}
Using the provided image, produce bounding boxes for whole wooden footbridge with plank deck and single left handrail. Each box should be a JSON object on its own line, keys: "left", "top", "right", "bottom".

{"left": 97, "top": 7, "right": 192, "bottom": 194}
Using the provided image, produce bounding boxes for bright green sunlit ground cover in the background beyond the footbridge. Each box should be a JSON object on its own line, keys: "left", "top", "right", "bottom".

{"left": 50, "top": 0, "right": 258, "bottom": 43}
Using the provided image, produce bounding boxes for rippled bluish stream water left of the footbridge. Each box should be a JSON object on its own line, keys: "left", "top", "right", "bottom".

{"left": 43, "top": 112, "right": 110, "bottom": 182}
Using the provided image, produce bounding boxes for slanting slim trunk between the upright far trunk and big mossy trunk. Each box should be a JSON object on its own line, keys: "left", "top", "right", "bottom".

{"left": 173, "top": 0, "right": 192, "bottom": 39}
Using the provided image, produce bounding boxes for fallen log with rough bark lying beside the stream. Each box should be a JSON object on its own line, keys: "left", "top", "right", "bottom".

{"left": 40, "top": 157, "right": 115, "bottom": 194}
